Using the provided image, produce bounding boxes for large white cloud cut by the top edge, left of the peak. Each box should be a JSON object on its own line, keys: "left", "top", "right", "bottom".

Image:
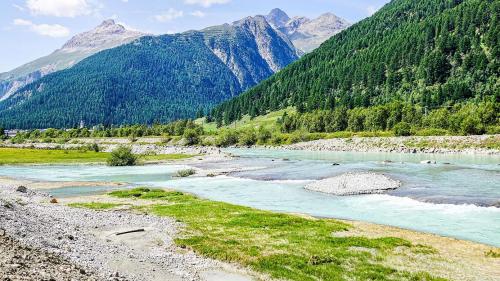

{"left": 26, "top": 0, "right": 100, "bottom": 18}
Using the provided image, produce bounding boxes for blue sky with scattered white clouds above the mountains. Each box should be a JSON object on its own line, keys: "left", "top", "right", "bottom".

{"left": 0, "top": 0, "right": 389, "bottom": 72}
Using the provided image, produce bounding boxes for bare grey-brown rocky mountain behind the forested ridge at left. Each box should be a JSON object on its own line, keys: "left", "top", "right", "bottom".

{"left": 0, "top": 20, "right": 145, "bottom": 100}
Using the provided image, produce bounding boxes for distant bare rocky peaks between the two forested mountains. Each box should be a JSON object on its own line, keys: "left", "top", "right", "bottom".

{"left": 266, "top": 9, "right": 351, "bottom": 53}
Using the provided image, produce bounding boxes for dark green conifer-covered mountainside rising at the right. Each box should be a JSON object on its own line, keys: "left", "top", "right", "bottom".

{"left": 213, "top": 0, "right": 500, "bottom": 123}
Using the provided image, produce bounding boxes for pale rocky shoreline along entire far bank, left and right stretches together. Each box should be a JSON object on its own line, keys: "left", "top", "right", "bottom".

{"left": 1, "top": 135, "right": 500, "bottom": 155}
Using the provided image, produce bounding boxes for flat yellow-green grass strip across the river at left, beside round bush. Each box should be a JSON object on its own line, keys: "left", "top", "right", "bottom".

{"left": 0, "top": 148, "right": 194, "bottom": 165}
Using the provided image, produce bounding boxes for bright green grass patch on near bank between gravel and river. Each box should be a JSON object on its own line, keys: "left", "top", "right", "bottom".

{"left": 110, "top": 188, "right": 444, "bottom": 281}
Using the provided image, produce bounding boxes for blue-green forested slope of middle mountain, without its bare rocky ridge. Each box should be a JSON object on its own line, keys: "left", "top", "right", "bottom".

{"left": 0, "top": 34, "right": 240, "bottom": 128}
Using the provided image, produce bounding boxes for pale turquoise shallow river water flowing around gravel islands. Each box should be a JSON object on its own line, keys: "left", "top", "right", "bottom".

{"left": 0, "top": 149, "right": 500, "bottom": 246}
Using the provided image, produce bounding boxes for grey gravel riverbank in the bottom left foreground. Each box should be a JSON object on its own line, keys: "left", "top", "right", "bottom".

{"left": 0, "top": 186, "right": 252, "bottom": 281}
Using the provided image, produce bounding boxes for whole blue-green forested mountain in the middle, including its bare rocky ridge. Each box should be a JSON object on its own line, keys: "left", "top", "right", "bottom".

{"left": 0, "top": 16, "right": 298, "bottom": 128}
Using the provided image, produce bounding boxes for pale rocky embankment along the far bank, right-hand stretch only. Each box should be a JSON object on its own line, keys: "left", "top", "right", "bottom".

{"left": 279, "top": 135, "right": 500, "bottom": 155}
